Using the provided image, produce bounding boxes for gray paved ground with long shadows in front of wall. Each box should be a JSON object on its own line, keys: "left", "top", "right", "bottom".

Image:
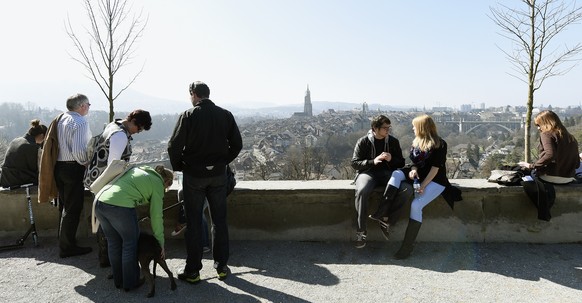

{"left": 0, "top": 237, "right": 582, "bottom": 303}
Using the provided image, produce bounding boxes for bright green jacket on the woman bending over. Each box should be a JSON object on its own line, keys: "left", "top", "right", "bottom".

{"left": 97, "top": 166, "right": 165, "bottom": 247}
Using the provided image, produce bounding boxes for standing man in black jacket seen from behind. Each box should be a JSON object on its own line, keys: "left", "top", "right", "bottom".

{"left": 168, "top": 81, "right": 242, "bottom": 284}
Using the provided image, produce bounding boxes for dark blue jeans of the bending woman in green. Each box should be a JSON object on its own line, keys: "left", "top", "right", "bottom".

{"left": 95, "top": 201, "right": 139, "bottom": 289}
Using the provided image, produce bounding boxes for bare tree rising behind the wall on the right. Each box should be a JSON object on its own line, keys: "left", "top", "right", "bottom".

{"left": 490, "top": 0, "right": 582, "bottom": 162}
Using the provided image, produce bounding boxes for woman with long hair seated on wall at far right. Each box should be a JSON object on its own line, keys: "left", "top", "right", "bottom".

{"left": 518, "top": 110, "right": 580, "bottom": 221}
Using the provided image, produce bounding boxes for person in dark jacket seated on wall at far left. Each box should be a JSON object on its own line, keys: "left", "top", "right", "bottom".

{"left": 0, "top": 119, "right": 47, "bottom": 187}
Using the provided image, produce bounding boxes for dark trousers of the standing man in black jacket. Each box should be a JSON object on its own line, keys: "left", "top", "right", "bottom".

{"left": 182, "top": 173, "right": 229, "bottom": 272}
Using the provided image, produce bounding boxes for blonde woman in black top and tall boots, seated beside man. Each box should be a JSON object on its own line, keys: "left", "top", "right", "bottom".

{"left": 376, "top": 115, "right": 462, "bottom": 259}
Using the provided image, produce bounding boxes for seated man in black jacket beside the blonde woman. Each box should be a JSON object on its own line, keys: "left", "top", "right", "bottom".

{"left": 352, "top": 115, "right": 412, "bottom": 248}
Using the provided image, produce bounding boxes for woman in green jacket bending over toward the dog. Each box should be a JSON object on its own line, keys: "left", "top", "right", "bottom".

{"left": 95, "top": 165, "right": 174, "bottom": 291}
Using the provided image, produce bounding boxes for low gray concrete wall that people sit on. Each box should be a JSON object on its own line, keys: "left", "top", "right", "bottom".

{"left": 0, "top": 179, "right": 582, "bottom": 243}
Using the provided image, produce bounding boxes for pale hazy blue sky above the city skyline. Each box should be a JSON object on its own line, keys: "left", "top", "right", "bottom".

{"left": 0, "top": 0, "right": 582, "bottom": 111}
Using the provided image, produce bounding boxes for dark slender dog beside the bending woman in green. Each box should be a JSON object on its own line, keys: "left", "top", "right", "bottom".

{"left": 137, "top": 232, "right": 176, "bottom": 298}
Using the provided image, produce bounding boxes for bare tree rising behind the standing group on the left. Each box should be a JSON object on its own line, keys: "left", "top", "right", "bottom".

{"left": 65, "top": 0, "right": 147, "bottom": 122}
